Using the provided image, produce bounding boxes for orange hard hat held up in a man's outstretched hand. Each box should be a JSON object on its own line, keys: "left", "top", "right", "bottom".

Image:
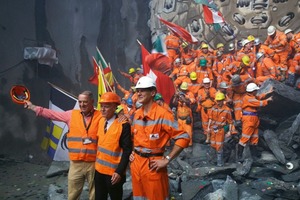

{"left": 10, "top": 85, "right": 30, "bottom": 104}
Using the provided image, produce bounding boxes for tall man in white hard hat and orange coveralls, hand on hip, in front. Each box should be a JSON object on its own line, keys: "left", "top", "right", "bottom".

{"left": 130, "top": 76, "right": 190, "bottom": 200}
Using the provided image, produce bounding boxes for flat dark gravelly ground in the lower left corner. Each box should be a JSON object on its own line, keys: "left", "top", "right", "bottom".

{"left": 0, "top": 158, "right": 59, "bottom": 200}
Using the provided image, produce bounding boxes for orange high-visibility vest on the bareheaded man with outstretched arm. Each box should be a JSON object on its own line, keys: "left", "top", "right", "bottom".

{"left": 67, "top": 110, "right": 101, "bottom": 162}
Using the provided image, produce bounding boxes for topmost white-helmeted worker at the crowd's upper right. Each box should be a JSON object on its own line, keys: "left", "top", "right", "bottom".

{"left": 264, "top": 26, "right": 289, "bottom": 78}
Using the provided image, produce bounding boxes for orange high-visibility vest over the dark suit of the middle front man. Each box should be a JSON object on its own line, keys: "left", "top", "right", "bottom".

{"left": 95, "top": 118, "right": 125, "bottom": 176}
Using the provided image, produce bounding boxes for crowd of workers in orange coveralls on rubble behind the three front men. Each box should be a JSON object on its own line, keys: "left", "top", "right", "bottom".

{"left": 117, "top": 26, "right": 300, "bottom": 169}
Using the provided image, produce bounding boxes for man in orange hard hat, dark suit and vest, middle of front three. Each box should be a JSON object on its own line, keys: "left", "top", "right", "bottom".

{"left": 95, "top": 92, "right": 132, "bottom": 200}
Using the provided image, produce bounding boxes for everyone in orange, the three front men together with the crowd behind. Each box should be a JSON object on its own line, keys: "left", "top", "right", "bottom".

{"left": 19, "top": 26, "right": 300, "bottom": 200}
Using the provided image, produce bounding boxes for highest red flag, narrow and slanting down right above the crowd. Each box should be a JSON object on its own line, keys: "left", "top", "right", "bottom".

{"left": 157, "top": 15, "right": 198, "bottom": 43}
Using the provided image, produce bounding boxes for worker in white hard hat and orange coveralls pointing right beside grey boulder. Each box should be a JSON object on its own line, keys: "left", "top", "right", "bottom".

{"left": 237, "top": 83, "right": 273, "bottom": 161}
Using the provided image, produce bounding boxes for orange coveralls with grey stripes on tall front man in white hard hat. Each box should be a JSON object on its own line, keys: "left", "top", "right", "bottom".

{"left": 130, "top": 103, "right": 190, "bottom": 200}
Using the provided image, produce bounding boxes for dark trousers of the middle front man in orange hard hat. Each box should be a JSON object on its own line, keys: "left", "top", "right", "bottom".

{"left": 95, "top": 171, "right": 125, "bottom": 200}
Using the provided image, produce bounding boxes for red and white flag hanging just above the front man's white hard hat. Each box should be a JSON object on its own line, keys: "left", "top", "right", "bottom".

{"left": 140, "top": 44, "right": 175, "bottom": 104}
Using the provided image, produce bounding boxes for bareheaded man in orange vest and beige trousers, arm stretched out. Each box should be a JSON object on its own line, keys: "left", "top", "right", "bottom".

{"left": 24, "top": 91, "right": 101, "bottom": 200}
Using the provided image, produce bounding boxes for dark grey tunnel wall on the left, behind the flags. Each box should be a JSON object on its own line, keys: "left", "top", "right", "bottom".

{"left": 0, "top": 0, "right": 150, "bottom": 160}
